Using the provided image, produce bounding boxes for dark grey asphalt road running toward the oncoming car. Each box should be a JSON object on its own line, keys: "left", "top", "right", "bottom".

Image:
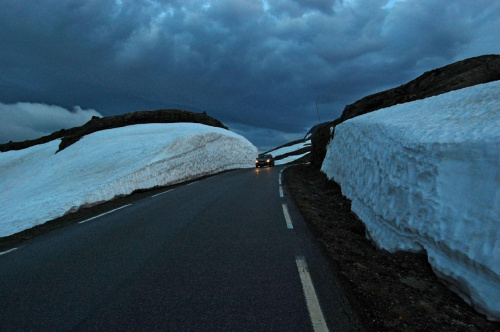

{"left": 0, "top": 167, "right": 360, "bottom": 331}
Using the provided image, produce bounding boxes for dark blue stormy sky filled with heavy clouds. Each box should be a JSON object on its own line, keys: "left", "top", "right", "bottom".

{"left": 0, "top": 0, "right": 500, "bottom": 151}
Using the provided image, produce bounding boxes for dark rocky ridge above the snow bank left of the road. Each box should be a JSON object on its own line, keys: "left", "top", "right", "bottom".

{"left": 0, "top": 109, "right": 228, "bottom": 152}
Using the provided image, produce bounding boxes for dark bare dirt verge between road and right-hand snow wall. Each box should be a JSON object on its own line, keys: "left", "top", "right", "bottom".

{"left": 284, "top": 165, "right": 500, "bottom": 331}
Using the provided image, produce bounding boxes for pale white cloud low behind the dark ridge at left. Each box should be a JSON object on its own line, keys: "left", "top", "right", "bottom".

{"left": 0, "top": 103, "right": 102, "bottom": 144}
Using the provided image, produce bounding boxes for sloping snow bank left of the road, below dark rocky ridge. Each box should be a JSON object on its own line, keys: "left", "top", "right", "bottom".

{"left": 0, "top": 123, "right": 257, "bottom": 237}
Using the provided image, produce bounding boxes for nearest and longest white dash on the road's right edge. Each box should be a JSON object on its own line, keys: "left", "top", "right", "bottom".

{"left": 295, "top": 256, "right": 328, "bottom": 332}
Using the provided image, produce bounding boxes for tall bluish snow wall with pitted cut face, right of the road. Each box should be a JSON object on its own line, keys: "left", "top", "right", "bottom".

{"left": 322, "top": 81, "right": 500, "bottom": 320}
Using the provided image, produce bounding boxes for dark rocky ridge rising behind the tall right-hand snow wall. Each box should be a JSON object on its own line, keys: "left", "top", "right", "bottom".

{"left": 311, "top": 55, "right": 500, "bottom": 169}
